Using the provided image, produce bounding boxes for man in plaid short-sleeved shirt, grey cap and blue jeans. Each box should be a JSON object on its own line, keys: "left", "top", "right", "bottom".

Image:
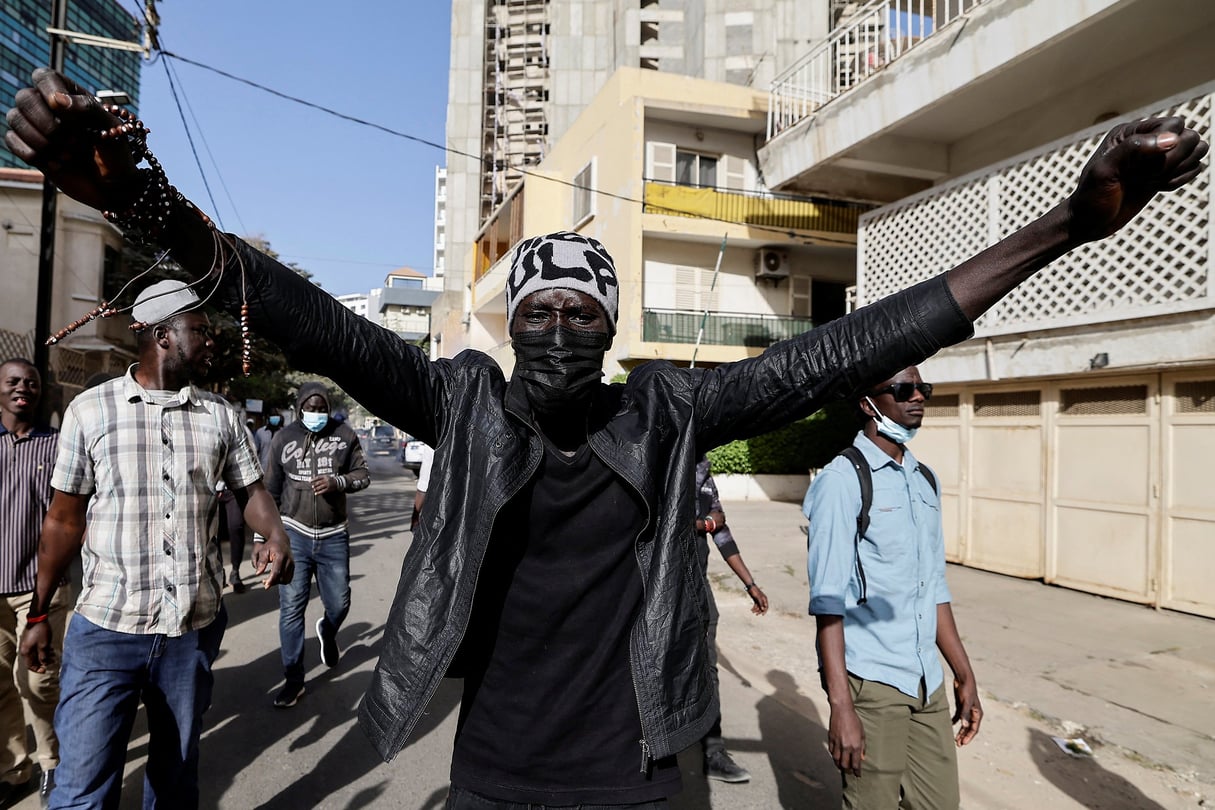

{"left": 21, "top": 282, "right": 292, "bottom": 810}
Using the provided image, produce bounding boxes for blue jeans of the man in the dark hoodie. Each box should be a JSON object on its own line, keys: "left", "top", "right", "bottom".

{"left": 278, "top": 527, "right": 350, "bottom": 684}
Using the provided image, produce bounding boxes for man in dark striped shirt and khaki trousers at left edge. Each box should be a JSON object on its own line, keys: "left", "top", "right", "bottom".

{"left": 0, "top": 357, "right": 72, "bottom": 804}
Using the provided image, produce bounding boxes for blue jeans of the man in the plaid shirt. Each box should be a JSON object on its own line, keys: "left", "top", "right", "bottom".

{"left": 51, "top": 606, "right": 227, "bottom": 810}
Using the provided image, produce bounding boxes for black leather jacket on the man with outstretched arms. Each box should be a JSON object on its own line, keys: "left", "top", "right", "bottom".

{"left": 225, "top": 239, "right": 971, "bottom": 759}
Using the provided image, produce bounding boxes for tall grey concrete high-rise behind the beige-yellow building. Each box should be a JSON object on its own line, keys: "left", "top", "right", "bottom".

{"left": 435, "top": 0, "right": 832, "bottom": 353}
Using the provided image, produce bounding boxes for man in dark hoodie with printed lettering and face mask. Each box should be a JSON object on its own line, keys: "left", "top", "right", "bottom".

{"left": 266, "top": 383, "right": 371, "bottom": 709}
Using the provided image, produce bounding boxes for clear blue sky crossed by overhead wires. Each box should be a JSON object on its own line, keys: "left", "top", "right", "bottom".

{"left": 129, "top": 0, "right": 451, "bottom": 295}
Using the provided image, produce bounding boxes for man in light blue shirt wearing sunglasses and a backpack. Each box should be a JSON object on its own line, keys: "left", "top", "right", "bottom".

{"left": 802, "top": 367, "right": 983, "bottom": 810}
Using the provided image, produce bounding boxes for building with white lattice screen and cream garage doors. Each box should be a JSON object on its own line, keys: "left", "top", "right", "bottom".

{"left": 759, "top": 0, "right": 1215, "bottom": 616}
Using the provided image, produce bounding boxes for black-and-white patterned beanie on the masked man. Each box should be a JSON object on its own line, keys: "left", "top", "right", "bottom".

{"left": 507, "top": 231, "right": 620, "bottom": 335}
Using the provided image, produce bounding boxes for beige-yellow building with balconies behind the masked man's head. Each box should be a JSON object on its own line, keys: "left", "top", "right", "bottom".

{"left": 456, "top": 68, "right": 868, "bottom": 375}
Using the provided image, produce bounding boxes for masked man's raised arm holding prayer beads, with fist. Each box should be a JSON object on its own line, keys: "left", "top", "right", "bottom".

{"left": 5, "top": 68, "right": 442, "bottom": 442}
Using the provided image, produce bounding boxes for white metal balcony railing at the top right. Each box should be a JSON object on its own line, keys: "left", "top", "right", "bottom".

{"left": 768, "top": 0, "right": 988, "bottom": 140}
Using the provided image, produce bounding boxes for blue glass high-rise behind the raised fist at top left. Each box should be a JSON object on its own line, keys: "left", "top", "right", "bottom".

{"left": 0, "top": 0, "right": 141, "bottom": 168}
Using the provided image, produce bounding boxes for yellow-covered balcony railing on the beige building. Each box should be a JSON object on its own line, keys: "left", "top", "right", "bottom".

{"left": 645, "top": 181, "right": 872, "bottom": 236}
